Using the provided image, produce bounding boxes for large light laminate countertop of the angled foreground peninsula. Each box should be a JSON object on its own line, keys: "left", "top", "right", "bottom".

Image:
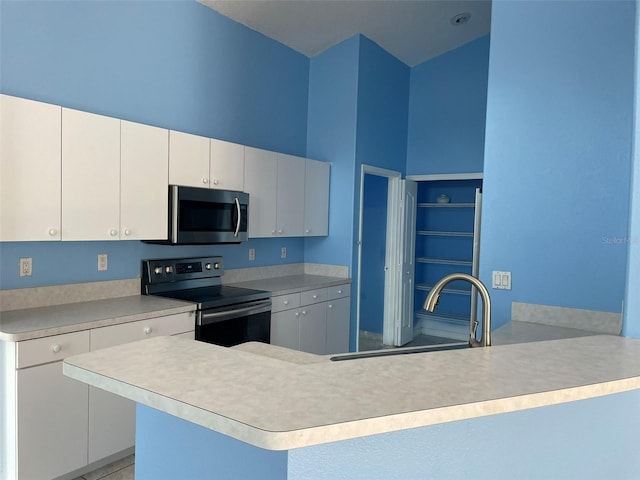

{"left": 63, "top": 335, "right": 640, "bottom": 450}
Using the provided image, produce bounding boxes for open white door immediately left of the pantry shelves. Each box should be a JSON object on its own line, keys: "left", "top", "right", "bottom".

{"left": 394, "top": 180, "right": 418, "bottom": 345}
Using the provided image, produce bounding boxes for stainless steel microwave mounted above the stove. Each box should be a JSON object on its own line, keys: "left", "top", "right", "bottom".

{"left": 153, "top": 185, "right": 249, "bottom": 245}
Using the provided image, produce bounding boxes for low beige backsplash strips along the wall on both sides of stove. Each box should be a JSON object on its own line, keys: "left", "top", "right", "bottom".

{"left": 0, "top": 263, "right": 349, "bottom": 311}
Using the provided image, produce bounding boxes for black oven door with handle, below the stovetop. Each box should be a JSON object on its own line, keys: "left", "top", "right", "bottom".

{"left": 196, "top": 299, "right": 271, "bottom": 347}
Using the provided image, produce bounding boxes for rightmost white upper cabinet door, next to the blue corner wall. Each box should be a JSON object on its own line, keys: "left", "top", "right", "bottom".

{"left": 304, "top": 160, "right": 331, "bottom": 237}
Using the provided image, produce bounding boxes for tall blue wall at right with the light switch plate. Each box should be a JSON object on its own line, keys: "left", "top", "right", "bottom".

{"left": 480, "top": 2, "right": 635, "bottom": 325}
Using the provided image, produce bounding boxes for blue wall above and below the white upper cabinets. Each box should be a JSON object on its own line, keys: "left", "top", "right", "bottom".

{"left": 0, "top": 1, "right": 310, "bottom": 289}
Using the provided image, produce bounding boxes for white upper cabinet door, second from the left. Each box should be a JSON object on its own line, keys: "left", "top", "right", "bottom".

{"left": 62, "top": 108, "right": 120, "bottom": 240}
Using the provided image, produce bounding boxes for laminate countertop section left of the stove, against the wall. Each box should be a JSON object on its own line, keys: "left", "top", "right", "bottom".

{"left": 0, "top": 295, "right": 196, "bottom": 342}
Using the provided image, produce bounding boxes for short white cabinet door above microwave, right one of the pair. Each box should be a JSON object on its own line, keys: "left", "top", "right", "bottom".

{"left": 209, "top": 138, "right": 244, "bottom": 192}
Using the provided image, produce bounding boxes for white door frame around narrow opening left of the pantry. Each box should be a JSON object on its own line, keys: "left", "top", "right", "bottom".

{"left": 356, "top": 164, "right": 402, "bottom": 350}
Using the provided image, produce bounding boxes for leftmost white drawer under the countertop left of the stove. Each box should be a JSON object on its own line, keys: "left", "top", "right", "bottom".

{"left": 16, "top": 330, "right": 89, "bottom": 368}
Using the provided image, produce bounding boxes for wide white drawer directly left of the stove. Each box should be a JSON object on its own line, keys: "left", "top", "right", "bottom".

{"left": 91, "top": 312, "right": 195, "bottom": 351}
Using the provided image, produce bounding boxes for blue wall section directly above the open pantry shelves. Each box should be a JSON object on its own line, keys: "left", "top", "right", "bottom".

{"left": 407, "top": 35, "right": 489, "bottom": 175}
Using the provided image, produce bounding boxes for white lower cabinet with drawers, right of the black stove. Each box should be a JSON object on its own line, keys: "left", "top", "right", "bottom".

{"left": 271, "top": 284, "right": 351, "bottom": 355}
